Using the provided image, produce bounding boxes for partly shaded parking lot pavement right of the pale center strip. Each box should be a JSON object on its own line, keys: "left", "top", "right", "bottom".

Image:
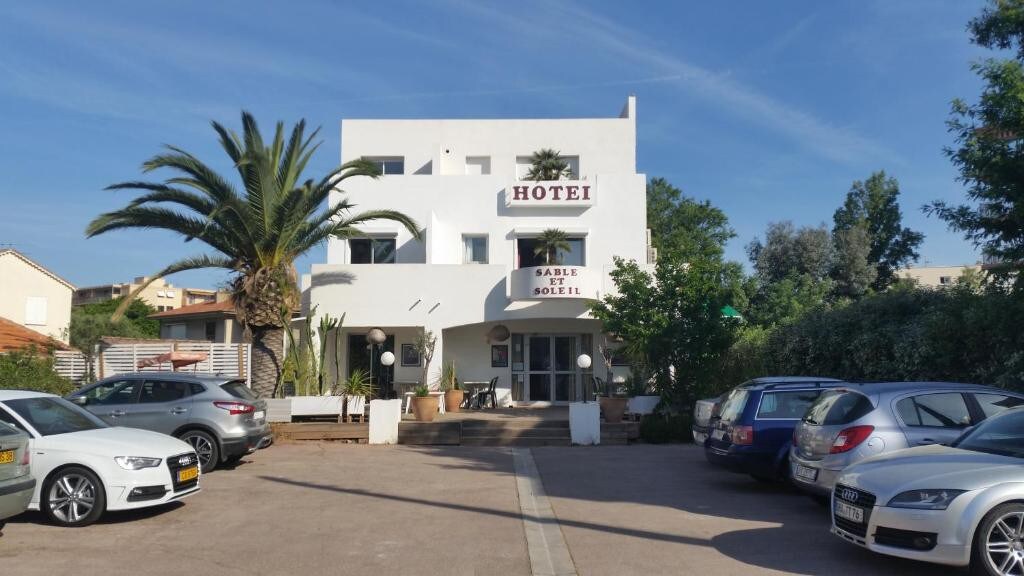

{"left": 534, "top": 445, "right": 957, "bottom": 576}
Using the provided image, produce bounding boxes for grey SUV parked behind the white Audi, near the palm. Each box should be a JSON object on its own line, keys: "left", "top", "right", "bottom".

{"left": 68, "top": 372, "right": 272, "bottom": 474}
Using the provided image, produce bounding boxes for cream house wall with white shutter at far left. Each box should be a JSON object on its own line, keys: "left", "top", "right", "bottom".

{"left": 0, "top": 248, "right": 75, "bottom": 343}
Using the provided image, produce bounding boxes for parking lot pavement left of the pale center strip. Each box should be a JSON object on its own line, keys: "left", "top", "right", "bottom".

{"left": 6, "top": 444, "right": 530, "bottom": 576}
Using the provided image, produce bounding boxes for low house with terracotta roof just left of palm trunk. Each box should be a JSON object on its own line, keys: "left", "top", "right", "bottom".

{"left": 150, "top": 295, "right": 243, "bottom": 343}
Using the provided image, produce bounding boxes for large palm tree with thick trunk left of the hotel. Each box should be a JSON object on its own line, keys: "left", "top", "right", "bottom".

{"left": 86, "top": 112, "right": 421, "bottom": 397}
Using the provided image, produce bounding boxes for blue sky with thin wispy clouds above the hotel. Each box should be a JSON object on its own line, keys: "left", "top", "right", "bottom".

{"left": 0, "top": 0, "right": 985, "bottom": 286}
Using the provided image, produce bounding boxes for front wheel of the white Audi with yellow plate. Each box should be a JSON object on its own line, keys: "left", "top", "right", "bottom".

{"left": 40, "top": 466, "right": 106, "bottom": 528}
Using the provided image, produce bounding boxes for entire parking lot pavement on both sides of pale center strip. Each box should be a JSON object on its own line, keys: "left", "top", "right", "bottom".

{"left": 0, "top": 444, "right": 954, "bottom": 576}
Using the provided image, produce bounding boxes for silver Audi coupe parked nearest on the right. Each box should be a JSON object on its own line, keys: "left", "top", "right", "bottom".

{"left": 833, "top": 408, "right": 1024, "bottom": 576}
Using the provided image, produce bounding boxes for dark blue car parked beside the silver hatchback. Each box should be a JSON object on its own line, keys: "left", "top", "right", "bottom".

{"left": 705, "top": 376, "right": 846, "bottom": 482}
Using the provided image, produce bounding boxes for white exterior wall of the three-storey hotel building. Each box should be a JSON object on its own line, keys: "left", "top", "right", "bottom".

{"left": 309, "top": 96, "right": 647, "bottom": 399}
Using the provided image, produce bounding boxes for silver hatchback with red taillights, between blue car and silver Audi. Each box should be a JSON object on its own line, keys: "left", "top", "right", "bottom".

{"left": 790, "top": 382, "right": 1024, "bottom": 497}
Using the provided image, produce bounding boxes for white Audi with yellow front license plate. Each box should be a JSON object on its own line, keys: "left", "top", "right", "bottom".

{"left": 0, "top": 390, "right": 200, "bottom": 527}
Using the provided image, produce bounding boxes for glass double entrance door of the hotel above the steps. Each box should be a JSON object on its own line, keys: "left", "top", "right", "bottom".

{"left": 525, "top": 335, "right": 578, "bottom": 402}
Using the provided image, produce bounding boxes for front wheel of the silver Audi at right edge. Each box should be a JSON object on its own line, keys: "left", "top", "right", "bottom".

{"left": 971, "top": 503, "right": 1024, "bottom": 576}
